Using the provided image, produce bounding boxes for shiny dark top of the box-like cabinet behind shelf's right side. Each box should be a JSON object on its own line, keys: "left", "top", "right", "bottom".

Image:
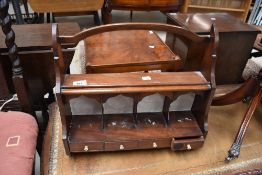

{"left": 167, "top": 13, "right": 259, "bottom": 34}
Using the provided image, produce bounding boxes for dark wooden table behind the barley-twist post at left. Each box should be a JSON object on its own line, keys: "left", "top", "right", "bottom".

{"left": 0, "top": 23, "right": 80, "bottom": 150}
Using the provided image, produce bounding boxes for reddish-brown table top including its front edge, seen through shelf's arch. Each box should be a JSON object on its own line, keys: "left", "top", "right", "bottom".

{"left": 85, "top": 30, "right": 181, "bottom": 73}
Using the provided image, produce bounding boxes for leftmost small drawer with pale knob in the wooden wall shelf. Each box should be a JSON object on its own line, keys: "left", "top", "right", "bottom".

{"left": 69, "top": 142, "right": 104, "bottom": 152}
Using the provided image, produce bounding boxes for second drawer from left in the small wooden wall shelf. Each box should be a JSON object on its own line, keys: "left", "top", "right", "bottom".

{"left": 105, "top": 141, "right": 138, "bottom": 151}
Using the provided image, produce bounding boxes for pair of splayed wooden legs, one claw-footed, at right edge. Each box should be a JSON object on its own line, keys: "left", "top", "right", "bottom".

{"left": 212, "top": 71, "right": 262, "bottom": 161}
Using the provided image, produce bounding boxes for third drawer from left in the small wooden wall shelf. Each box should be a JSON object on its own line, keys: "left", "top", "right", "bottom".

{"left": 139, "top": 139, "right": 171, "bottom": 149}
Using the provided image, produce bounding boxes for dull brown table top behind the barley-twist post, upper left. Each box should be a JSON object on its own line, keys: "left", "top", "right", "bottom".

{"left": 0, "top": 22, "right": 80, "bottom": 52}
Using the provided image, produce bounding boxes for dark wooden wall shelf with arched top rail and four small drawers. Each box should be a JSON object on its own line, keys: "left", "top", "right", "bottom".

{"left": 53, "top": 23, "right": 218, "bottom": 154}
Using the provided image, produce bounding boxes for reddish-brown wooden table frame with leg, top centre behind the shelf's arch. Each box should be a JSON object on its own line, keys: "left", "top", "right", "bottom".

{"left": 102, "top": 0, "right": 184, "bottom": 24}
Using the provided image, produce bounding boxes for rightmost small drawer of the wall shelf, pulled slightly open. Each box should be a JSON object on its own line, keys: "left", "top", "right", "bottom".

{"left": 171, "top": 137, "right": 204, "bottom": 151}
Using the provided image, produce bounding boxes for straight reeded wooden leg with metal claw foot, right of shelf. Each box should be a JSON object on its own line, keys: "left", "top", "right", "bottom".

{"left": 225, "top": 87, "right": 262, "bottom": 162}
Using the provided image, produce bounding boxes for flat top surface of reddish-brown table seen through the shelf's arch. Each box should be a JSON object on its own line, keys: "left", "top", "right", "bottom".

{"left": 85, "top": 30, "right": 180, "bottom": 66}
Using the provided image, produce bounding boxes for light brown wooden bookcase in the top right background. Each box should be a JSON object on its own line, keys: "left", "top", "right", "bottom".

{"left": 182, "top": 0, "right": 252, "bottom": 21}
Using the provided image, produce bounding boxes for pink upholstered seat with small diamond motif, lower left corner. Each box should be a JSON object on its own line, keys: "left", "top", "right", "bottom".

{"left": 0, "top": 112, "right": 38, "bottom": 175}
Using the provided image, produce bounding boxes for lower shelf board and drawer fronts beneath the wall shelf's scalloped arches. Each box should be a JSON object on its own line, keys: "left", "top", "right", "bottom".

{"left": 68, "top": 111, "right": 204, "bottom": 152}
